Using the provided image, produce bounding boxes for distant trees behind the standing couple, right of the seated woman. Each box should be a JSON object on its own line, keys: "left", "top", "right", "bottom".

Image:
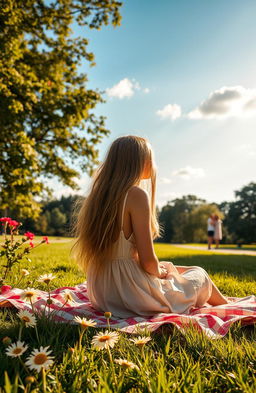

{"left": 158, "top": 182, "right": 256, "bottom": 244}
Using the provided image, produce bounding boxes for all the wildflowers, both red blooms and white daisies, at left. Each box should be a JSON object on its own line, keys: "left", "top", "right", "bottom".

{"left": 0, "top": 217, "right": 151, "bottom": 393}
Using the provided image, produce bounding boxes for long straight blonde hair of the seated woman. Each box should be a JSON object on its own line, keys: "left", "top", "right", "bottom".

{"left": 73, "top": 135, "right": 159, "bottom": 272}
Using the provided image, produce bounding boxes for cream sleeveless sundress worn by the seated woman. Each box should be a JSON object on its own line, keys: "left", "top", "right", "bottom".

{"left": 87, "top": 192, "right": 212, "bottom": 318}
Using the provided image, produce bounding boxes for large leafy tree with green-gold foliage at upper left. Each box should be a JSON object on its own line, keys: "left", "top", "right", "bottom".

{"left": 0, "top": 0, "right": 121, "bottom": 217}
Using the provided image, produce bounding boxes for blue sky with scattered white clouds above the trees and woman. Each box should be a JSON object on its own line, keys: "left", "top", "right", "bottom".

{"left": 53, "top": 0, "right": 256, "bottom": 206}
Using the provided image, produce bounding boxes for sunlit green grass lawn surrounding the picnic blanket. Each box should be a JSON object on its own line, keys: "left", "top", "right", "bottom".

{"left": 0, "top": 239, "right": 256, "bottom": 393}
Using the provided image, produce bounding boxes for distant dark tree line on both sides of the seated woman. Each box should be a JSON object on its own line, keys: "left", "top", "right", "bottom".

{"left": 0, "top": 183, "right": 256, "bottom": 244}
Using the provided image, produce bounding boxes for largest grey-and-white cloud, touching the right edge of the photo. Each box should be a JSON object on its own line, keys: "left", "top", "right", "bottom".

{"left": 188, "top": 86, "right": 256, "bottom": 119}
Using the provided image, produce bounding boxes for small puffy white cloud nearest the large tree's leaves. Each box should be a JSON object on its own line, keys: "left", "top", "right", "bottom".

{"left": 106, "top": 78, "right": 150, "bottom": 100}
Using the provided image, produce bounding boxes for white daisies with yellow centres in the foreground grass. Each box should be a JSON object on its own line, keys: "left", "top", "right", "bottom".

{"left": 2, "top": 272, "right": 151, "bottom": 392}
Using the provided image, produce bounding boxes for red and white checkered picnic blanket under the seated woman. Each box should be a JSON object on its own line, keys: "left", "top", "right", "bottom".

{"left": 0, "top": 282, "right": 256, "bottom": 338}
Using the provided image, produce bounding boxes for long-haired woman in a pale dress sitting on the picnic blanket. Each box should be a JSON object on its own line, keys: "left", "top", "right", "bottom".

{"left": 74, "top": 135, "right": 228, "bottom": 318}
